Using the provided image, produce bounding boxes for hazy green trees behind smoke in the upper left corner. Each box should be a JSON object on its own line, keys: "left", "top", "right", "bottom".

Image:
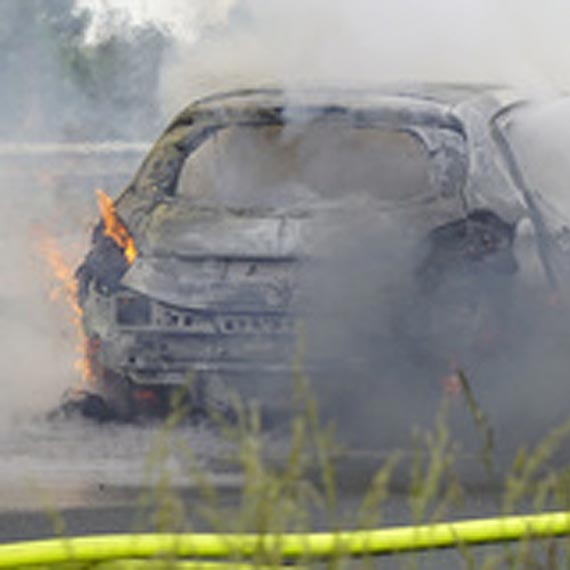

{"left": 0, "top": 0, "right": 170, "bottom": 140}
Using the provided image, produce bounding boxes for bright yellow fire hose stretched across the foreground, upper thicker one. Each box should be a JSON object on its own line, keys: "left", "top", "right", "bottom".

{"left": 0, "top": 512, "right": 570, "bottom": 569}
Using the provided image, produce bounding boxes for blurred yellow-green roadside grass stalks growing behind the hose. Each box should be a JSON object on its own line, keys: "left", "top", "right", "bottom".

{"left": 124, "top": 378, "right": 570, "bottom": 570}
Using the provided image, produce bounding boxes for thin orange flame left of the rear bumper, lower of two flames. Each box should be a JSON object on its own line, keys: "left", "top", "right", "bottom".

{"left": 40, "top": 235, "right": 95, "bottom": 382}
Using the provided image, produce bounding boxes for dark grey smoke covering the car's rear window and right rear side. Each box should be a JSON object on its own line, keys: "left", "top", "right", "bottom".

{"left": 172, "top": 108, "right": 569, "bottom": 460}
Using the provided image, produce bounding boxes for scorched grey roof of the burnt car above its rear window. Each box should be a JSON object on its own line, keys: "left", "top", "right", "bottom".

{"left": 117, "top": 83, "right": 526, "bottom": 234}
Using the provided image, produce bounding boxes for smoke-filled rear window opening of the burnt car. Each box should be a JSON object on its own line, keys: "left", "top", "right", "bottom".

{"left": 177, "top": 122, "right": 440, "bottom": 208}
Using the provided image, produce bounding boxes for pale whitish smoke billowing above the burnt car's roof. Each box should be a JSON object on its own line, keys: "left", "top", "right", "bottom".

{"left": 158, "top": 0, "right": 570, "bottom": 113}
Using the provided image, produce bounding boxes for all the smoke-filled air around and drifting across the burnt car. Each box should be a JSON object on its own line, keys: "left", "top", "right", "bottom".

{"left": 0, "top": 0, "right": 570, "bottom": 468}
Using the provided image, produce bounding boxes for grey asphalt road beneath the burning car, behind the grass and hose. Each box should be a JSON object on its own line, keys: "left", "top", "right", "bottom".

{"left": 0, "top": 398, "right": 560, "bottom": 569}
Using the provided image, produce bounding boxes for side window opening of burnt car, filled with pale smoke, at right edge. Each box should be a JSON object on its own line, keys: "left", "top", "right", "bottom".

{"left": 500, "top": 99, "right": 570, "bottom": 218}
